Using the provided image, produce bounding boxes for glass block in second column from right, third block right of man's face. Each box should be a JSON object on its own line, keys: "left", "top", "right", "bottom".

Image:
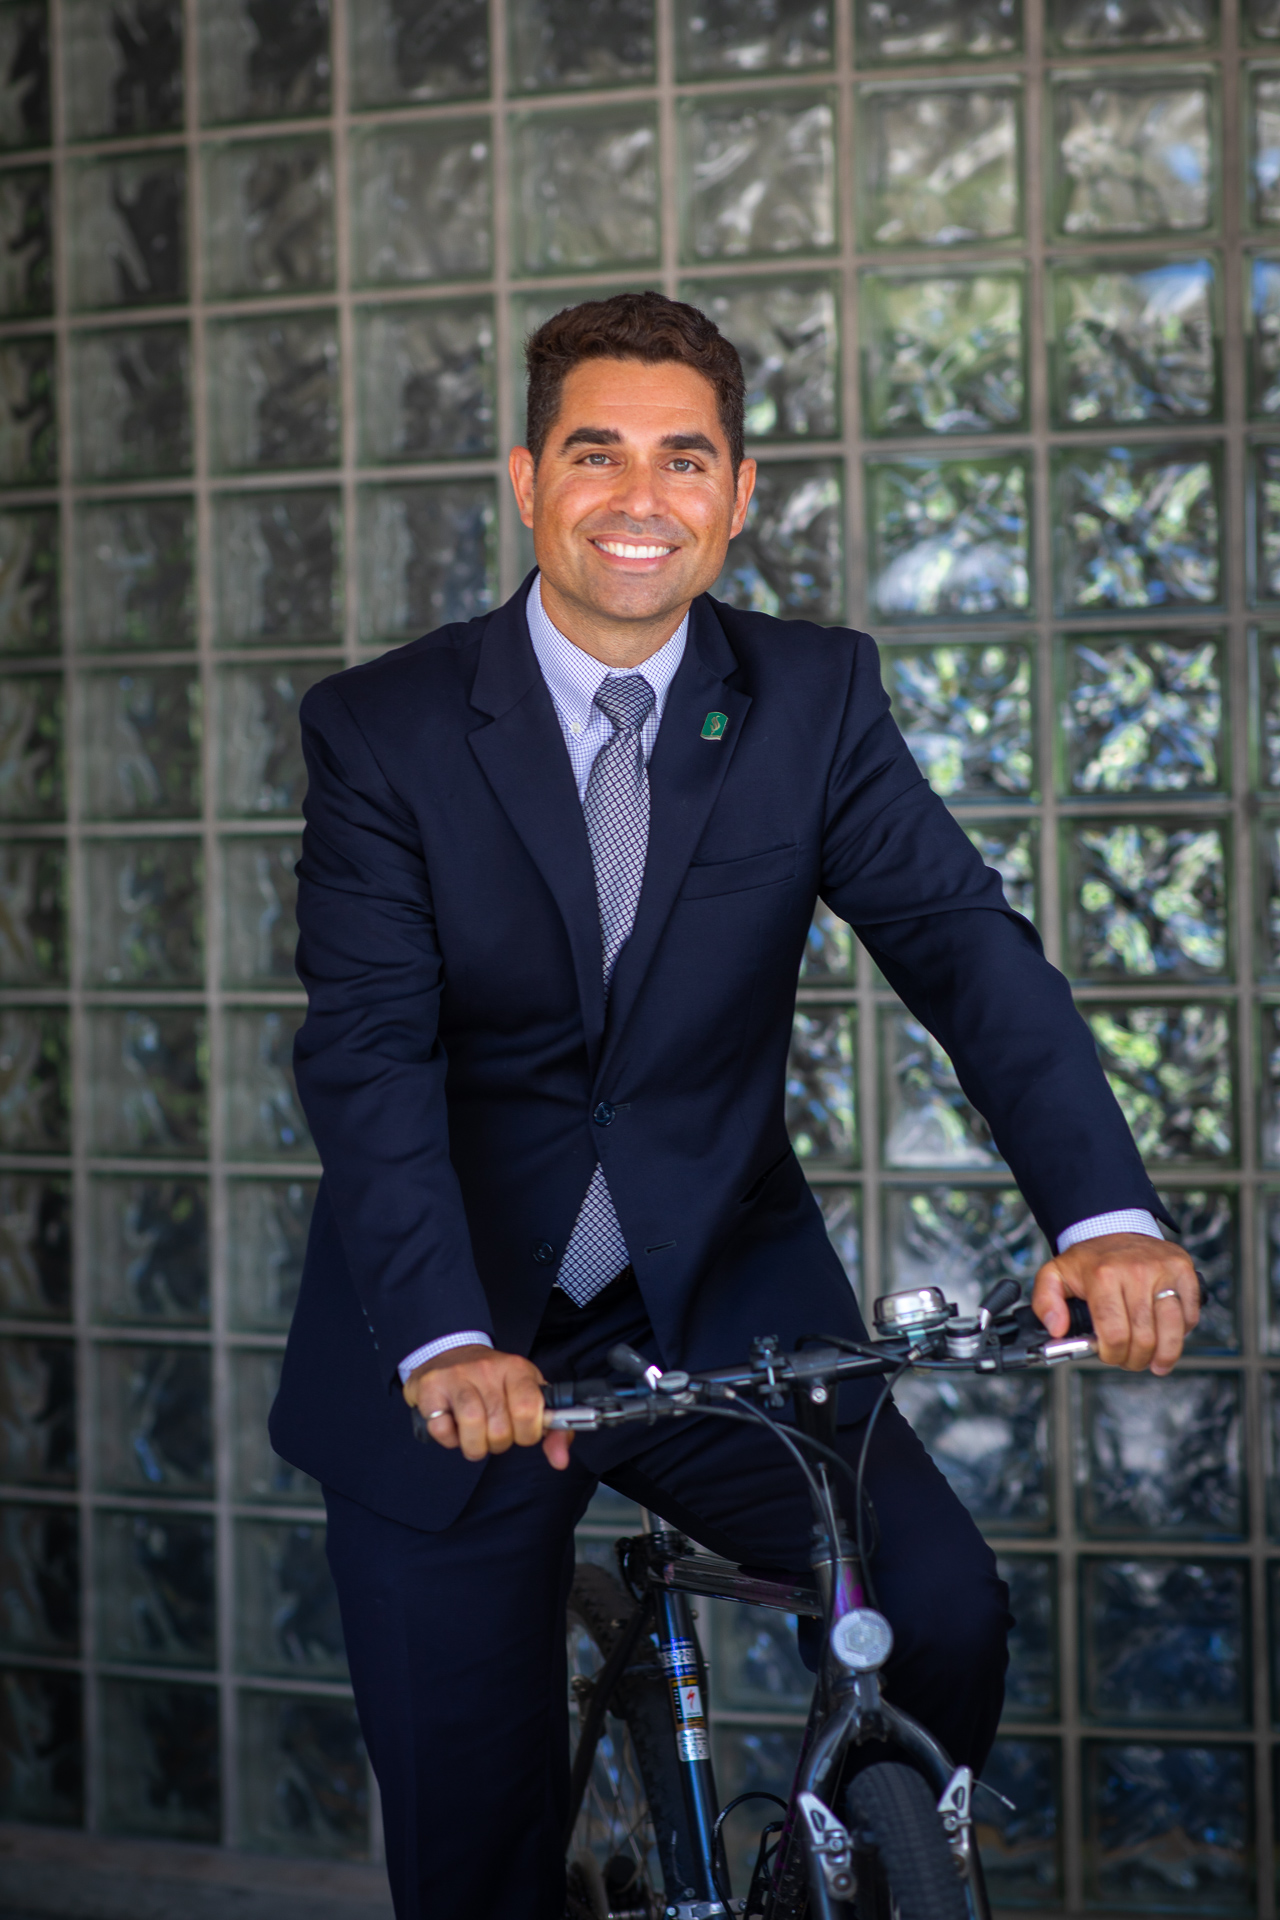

{"left": 1054, "top": 445, "right": 1221, "bottom": 614}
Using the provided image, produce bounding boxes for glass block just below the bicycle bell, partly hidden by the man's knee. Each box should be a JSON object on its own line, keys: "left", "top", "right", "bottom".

{"left": 894, "top": 1373, "right": 1054, "bottom": 1534}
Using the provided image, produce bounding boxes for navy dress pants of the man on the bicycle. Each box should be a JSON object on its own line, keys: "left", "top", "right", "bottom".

{"left": 324, "top": 1277, "right": 1011, "bottom": 1920}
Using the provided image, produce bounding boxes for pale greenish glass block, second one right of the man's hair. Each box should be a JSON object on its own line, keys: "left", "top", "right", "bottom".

{"left": 862, "top": 273, "right": 1027, "bottom": 434}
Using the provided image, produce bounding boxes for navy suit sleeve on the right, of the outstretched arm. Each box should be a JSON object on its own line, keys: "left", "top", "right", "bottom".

{"left": 821, "top": 636, "right": 1173, "bottom": 1246}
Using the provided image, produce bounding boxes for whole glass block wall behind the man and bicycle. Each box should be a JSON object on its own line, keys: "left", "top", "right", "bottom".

{"left": 0, "top": 0, "right": 1280, "bottom": 1914}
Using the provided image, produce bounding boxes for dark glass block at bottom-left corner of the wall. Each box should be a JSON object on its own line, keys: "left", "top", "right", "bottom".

{"left": 0, "top": 1674, "right": 84, "bottom": 1826}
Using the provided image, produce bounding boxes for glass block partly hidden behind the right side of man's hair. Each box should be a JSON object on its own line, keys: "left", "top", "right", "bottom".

{"left": 681, "top": 275, "right": 841, "bottom": 440}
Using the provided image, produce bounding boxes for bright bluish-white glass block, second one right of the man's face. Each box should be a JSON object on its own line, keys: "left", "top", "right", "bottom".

{"left": 867, "top": 453, "right": 1031, "bottom": 622}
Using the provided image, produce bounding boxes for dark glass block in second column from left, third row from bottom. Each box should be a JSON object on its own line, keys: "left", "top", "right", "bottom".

{"left": 94, "top": 1346, "right": 213, "bottom": 1500}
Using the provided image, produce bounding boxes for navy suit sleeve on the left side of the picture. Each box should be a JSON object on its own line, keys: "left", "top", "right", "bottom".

{"left": 294, "top": 682, "right": 491, "bottom": 1382}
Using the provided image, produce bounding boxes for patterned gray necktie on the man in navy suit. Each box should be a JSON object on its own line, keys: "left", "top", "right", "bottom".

{"left": 557, "top": 674, "right": 654, "bottom": 1308}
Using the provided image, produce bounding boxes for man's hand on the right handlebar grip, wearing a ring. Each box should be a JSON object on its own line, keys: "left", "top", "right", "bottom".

{"left": 1031, "top": 1233, "right": 1199, "bottom": 1375}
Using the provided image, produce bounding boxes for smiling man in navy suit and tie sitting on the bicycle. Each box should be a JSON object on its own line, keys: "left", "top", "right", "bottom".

{"left": 273, "top": 294, "right": 1199, "bottom": 1920}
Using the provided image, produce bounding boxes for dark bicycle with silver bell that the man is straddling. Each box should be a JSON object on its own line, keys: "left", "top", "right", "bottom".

{"left": 543, "top": 1281, "right": 1098, "bottom": 1920}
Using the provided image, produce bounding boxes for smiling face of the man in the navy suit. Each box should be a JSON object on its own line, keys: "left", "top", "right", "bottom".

{"left": 510, "top": 359, "right": 756, "bottom": 622}
